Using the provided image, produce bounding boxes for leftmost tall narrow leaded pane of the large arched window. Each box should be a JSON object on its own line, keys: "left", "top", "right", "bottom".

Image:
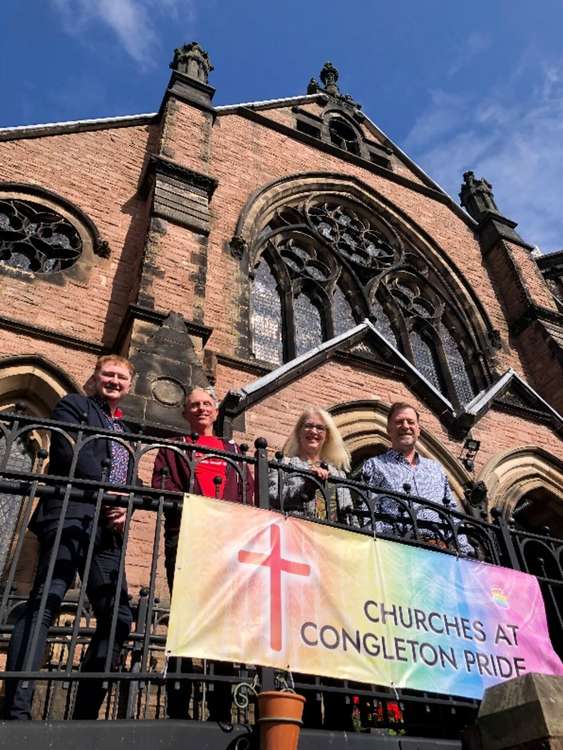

{"left": 251, "top": 260, "right": 283, "bottom": 365}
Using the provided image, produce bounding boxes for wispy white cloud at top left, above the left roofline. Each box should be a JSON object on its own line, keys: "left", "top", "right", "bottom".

{"left": 51, "top": 0, "right": 194, "bottom": 68}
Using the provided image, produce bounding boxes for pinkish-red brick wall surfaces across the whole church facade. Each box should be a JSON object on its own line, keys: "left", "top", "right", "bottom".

{"left": 0, "top": 88, "right": 563, "bottom": 604}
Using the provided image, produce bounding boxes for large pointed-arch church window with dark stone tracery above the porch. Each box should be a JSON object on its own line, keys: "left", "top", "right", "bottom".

{"left": 251, "top": 194, "right": 484, "bottom": 404}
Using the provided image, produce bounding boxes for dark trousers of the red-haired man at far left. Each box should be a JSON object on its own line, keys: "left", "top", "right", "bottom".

{"left": 4, "top": 519, "right": 132, "bottom": 719}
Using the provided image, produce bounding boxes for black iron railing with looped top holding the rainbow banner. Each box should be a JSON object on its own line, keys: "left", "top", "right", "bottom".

{"left": 0, "top": 413, "right": 563, "bottom": 737}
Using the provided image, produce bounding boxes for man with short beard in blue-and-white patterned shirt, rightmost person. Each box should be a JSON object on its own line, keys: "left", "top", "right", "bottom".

{"left": 362, "top": 402, "right": 460, "bottom": 547}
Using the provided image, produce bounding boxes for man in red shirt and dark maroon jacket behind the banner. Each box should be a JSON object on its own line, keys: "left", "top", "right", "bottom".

{"left": 152, "top": 387, "right": 254, "bottom": 722}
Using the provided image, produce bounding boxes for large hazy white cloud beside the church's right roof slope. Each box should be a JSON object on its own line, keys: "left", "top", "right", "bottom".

{"left": 406, "top": 59, "right": 563, "bottom": 251}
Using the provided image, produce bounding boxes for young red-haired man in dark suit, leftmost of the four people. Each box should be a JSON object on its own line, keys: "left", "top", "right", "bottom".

{"left": 4, "top": 355, "right": 134, "bottom": 719}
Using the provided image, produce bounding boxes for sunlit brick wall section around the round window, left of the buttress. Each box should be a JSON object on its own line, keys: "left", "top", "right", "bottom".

{"left": 0, "top": 126, "right": 154, "bottom": 346}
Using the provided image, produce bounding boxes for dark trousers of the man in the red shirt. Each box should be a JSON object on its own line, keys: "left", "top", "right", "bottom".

{"left": 164, "top": 514, "right": 235, "bottom": 723}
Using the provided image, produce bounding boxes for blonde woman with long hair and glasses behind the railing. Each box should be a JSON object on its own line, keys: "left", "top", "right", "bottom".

{"left": 270, "top": 406, "right": 352, "bottom": 520}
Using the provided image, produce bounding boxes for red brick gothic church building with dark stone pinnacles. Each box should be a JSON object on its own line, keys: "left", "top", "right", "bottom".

{"left": 0, "top": 43, "right": 563, "bottom": 600}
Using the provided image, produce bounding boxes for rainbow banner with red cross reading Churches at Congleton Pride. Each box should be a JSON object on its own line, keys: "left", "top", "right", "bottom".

{"left": 166, "top": 495, "right": 563, "bottom": 698}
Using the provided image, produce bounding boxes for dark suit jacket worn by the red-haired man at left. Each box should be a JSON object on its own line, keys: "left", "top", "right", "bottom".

{"left": 29, "top": 393, "right": 131, "bottom": 533}
